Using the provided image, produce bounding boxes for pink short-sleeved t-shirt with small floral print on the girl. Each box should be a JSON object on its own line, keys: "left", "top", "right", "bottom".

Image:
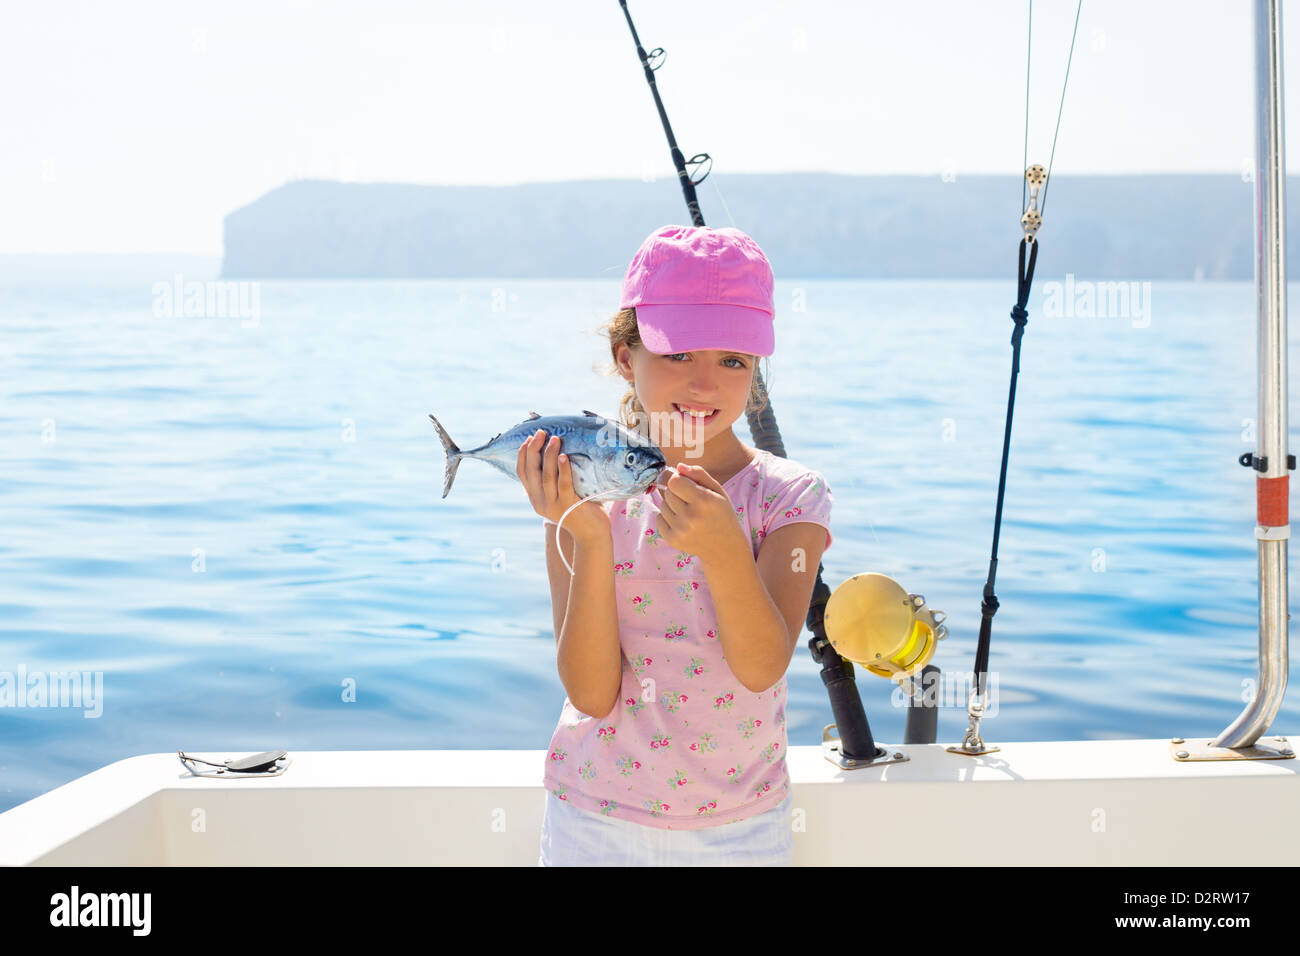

{"left": 545, "top": 449, "right": 832, "bottom": 830}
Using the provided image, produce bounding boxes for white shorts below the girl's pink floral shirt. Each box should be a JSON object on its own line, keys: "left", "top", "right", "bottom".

{"left": 537, "top": 791, "right": 794, "bottom": 866}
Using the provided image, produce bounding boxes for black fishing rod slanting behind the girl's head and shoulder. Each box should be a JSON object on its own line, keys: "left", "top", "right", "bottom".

{"left": 619, "top": 0, "right": 889, "bottom": 769}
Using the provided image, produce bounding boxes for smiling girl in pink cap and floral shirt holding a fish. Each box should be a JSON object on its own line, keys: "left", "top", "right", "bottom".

{"left": 517, "top": 226, "right": 832, "bottom": 866}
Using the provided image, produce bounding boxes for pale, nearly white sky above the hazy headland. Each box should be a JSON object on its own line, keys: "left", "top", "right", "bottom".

{"left": 0, "top": 0, "right": 1300, "bottom": 255}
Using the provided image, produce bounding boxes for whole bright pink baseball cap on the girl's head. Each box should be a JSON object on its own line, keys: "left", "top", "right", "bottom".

{"left": 619, "top": 226, "right": 776, "bottom": 355}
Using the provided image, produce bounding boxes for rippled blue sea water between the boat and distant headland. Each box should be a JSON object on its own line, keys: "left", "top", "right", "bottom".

{"left": 0, "top": 274, "right": 1300, "bottom": 809}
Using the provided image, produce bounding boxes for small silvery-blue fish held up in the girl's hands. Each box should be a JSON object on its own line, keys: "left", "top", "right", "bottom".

{"left": 429, "top": 408, "right": 667, "bottom": 501}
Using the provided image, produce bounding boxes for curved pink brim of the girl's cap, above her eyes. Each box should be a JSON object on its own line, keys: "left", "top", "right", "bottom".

{"left": 636, "top": 303, "right": 776, "bottom": 355}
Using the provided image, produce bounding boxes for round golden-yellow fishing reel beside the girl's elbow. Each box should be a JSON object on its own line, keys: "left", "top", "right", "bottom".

{"left": 823, "top": 572, "right": 948, "bottom": 697}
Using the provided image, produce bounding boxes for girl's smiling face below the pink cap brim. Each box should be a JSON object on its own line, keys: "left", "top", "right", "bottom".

{"left": 619, "top": 346, "right": 758, "bottom": 447}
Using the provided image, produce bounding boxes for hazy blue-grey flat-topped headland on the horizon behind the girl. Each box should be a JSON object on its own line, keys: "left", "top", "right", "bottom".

{"left": 221, "top": 172, "right": 1279, "bottom": 281}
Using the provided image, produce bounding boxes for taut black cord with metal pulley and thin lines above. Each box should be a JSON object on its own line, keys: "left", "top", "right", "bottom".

{"left": 948, "top": 0, "right": 1083, "bottom": 756}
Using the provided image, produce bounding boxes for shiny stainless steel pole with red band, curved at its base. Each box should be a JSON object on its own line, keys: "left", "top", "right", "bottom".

{"left": 1210, "top": 0, "right": 1291, "bottom": 748}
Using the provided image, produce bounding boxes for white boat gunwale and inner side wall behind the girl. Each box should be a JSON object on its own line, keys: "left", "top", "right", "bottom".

{"left": 0, "top": 737, "right": 1300, "bottom": 866}
